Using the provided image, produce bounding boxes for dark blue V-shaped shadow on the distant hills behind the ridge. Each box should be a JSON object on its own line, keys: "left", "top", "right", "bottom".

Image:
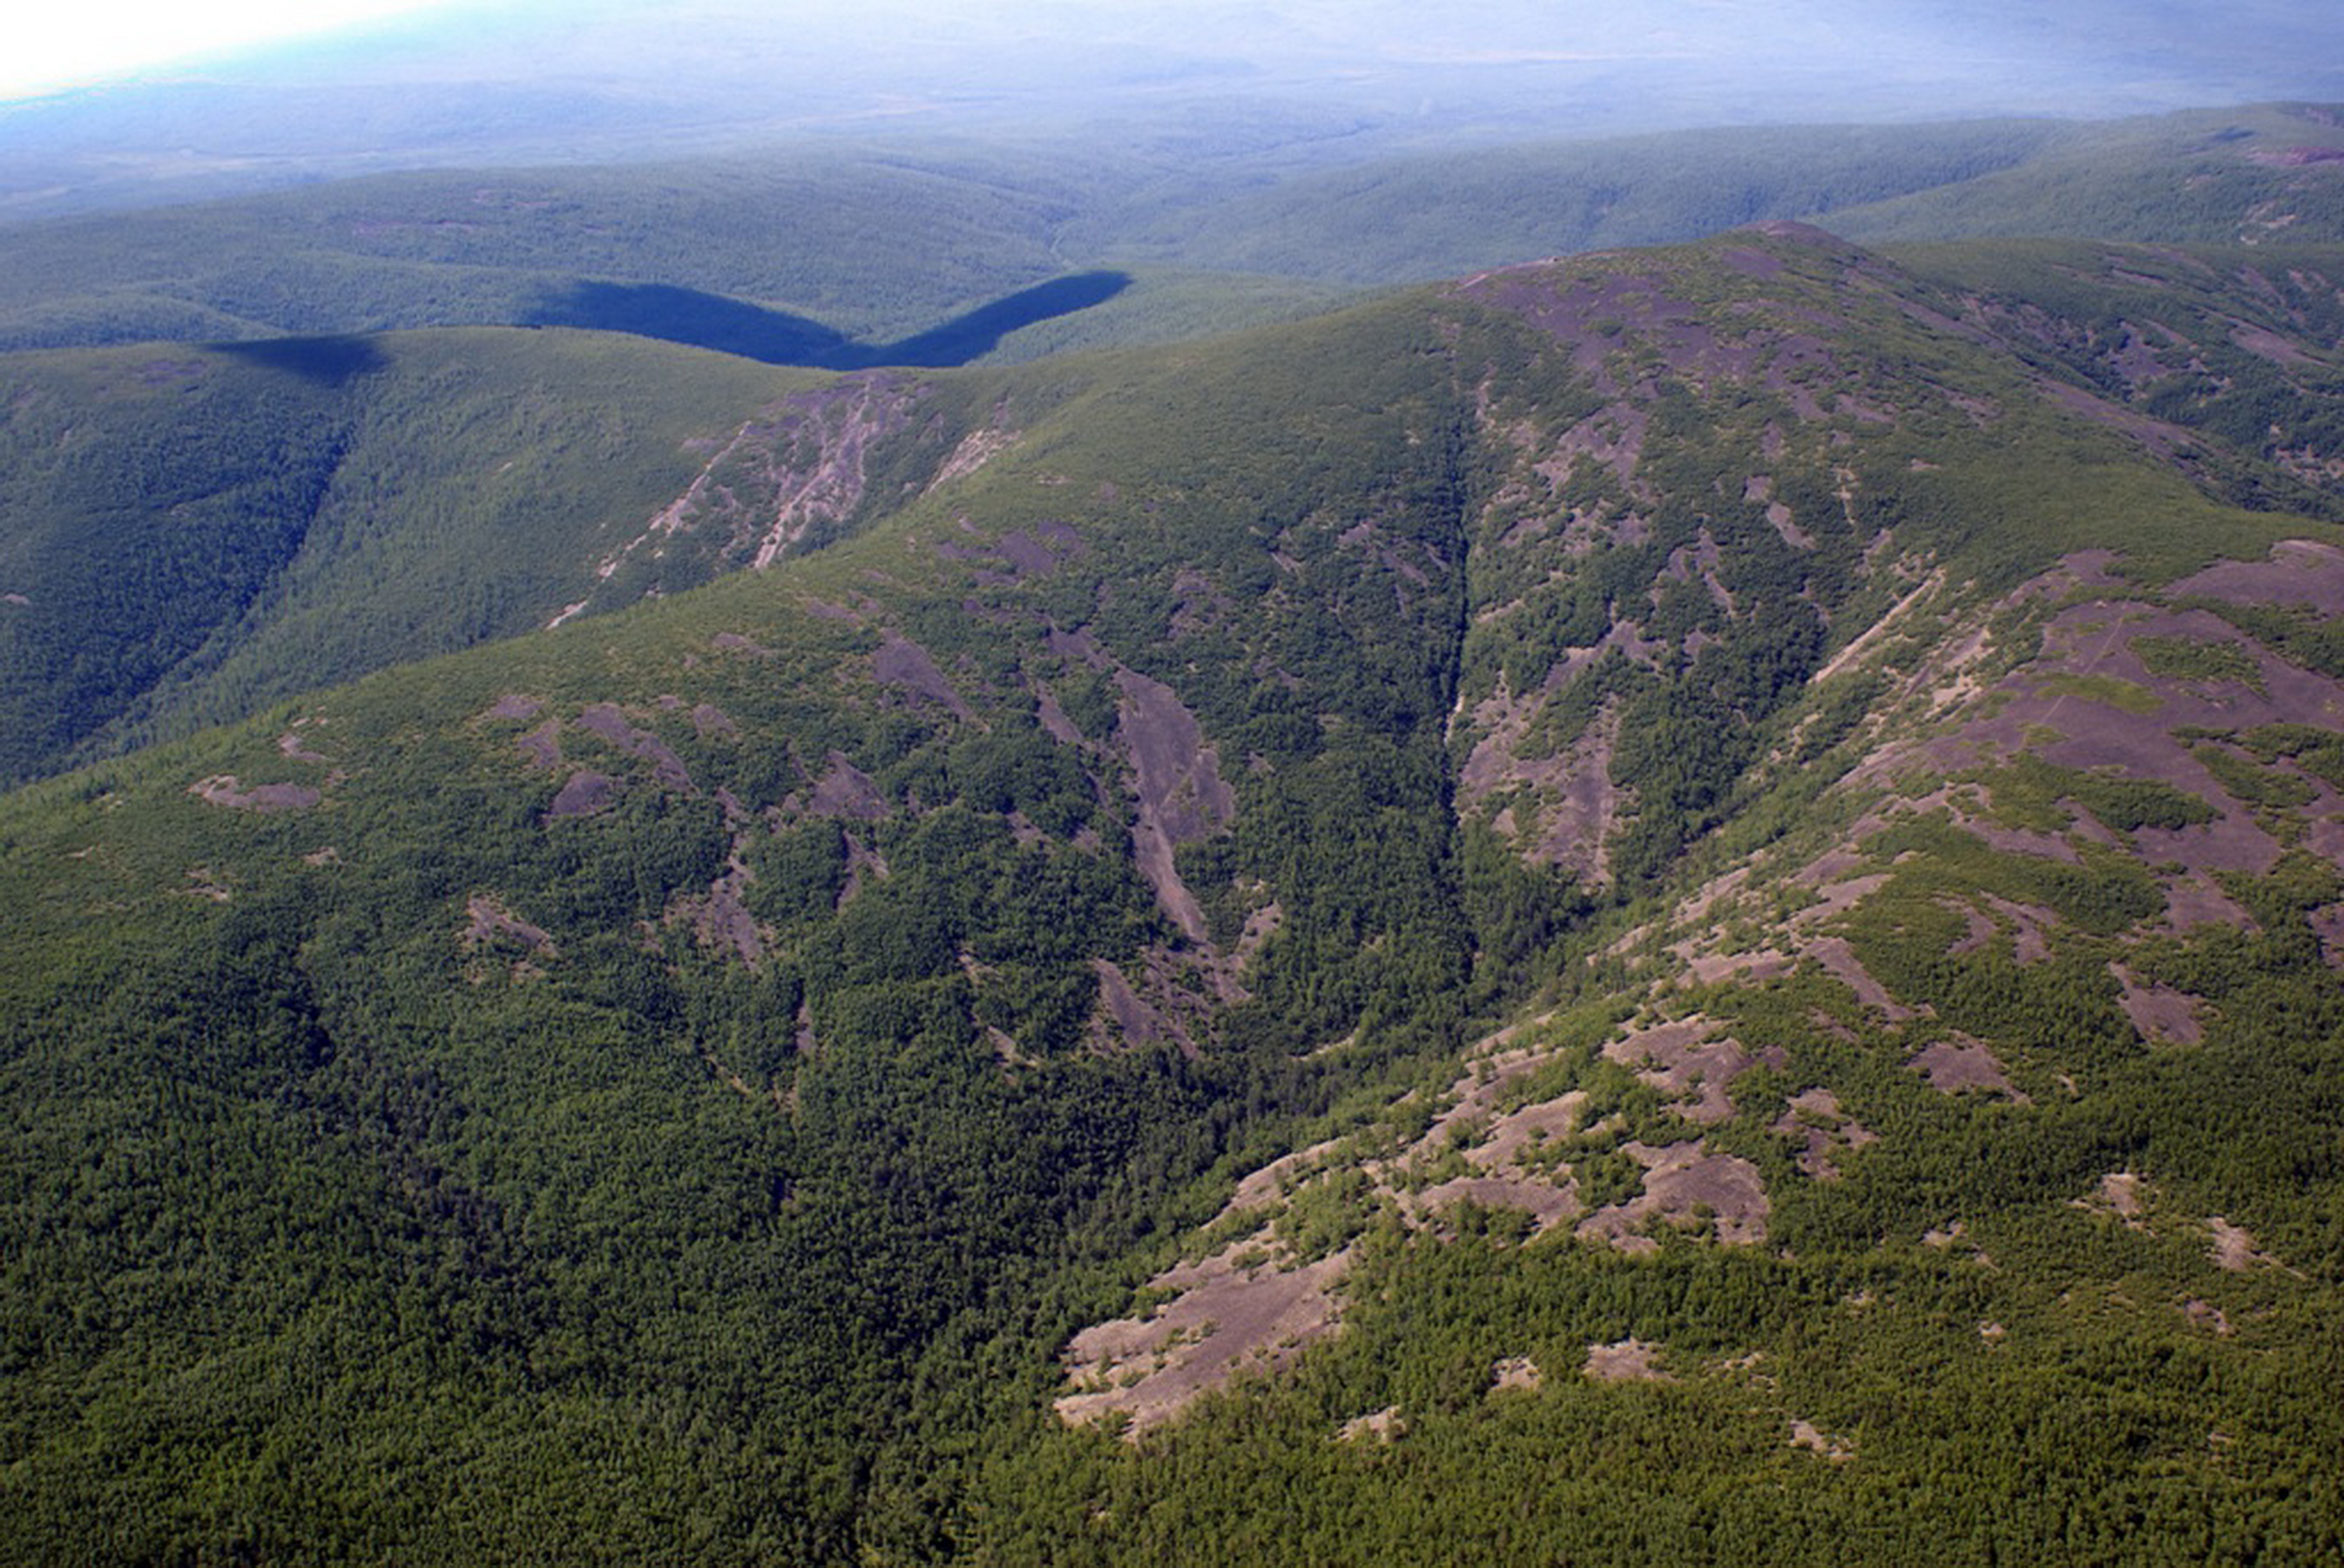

{"left": 520, "top": 272, "right": 1132, "bottom": 370}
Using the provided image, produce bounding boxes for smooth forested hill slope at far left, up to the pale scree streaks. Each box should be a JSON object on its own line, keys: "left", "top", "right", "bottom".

{"left": 0, "top": 330, "right": 807, "bottom": 783}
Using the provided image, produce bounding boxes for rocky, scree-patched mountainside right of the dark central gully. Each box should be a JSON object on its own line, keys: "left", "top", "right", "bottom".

{"left": 983, "top": 234, "right": 2344, "bottom": 1564}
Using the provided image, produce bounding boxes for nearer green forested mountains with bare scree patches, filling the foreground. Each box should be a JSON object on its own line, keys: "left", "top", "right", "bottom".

{"left": 0, "top": 223, "right": 2344, "bottom": 1564}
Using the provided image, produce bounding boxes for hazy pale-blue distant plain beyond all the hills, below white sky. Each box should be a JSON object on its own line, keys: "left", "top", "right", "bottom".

{"left": 0, "top": 0, "right": 2344, "bottom": 216}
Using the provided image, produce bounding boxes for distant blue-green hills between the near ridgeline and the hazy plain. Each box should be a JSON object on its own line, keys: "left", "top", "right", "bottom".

{"left": 0, "top": 103, "right": 2344, "bottom": 368}
